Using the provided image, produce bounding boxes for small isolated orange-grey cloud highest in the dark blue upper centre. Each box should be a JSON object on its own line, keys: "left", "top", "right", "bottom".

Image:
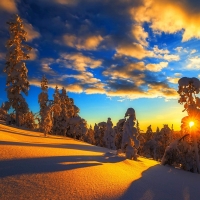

{"left": 63, "top": 34, "right": 103, "bottom": 50}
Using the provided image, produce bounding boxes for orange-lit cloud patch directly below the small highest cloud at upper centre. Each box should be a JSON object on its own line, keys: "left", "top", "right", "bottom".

{"left": 59, "top": 53, "right": 102, "bottom": 71}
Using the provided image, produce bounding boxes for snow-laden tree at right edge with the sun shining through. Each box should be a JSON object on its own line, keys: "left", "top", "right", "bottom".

{"left": 162, "top": 77, "right": 200, "bottom": 173}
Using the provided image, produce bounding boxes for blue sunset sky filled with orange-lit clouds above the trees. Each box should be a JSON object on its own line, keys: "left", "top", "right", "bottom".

{"left": 0, "top": 0, "right": 200, "bottom": 131}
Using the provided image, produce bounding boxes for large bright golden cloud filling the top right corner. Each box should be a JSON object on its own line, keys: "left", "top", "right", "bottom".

{"left": 130, "top": 0, "right": 200, "bottom": 42}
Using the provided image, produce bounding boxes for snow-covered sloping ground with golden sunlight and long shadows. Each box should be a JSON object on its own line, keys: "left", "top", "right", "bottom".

{"left": 0, "top": 124, "right": 200, "bottom": 200}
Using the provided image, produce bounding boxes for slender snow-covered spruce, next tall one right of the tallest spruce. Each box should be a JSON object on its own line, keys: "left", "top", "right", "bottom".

{"left": 38, "top": 76, "right": 53, "bottom": 136}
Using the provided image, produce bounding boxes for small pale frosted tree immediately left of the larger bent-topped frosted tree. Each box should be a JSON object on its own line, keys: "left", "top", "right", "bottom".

{"left": 104, "top": 118, "right": 116, "bottom": 149}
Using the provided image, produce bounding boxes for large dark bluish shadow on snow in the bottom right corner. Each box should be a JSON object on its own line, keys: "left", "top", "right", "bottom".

{"left": 118, "top": 165, "right": 200, "bottom": 200}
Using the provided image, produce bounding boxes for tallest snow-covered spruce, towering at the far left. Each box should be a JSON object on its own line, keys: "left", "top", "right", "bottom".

{"left": 4, "top": 15, "right": 31, "bottom": 126}
